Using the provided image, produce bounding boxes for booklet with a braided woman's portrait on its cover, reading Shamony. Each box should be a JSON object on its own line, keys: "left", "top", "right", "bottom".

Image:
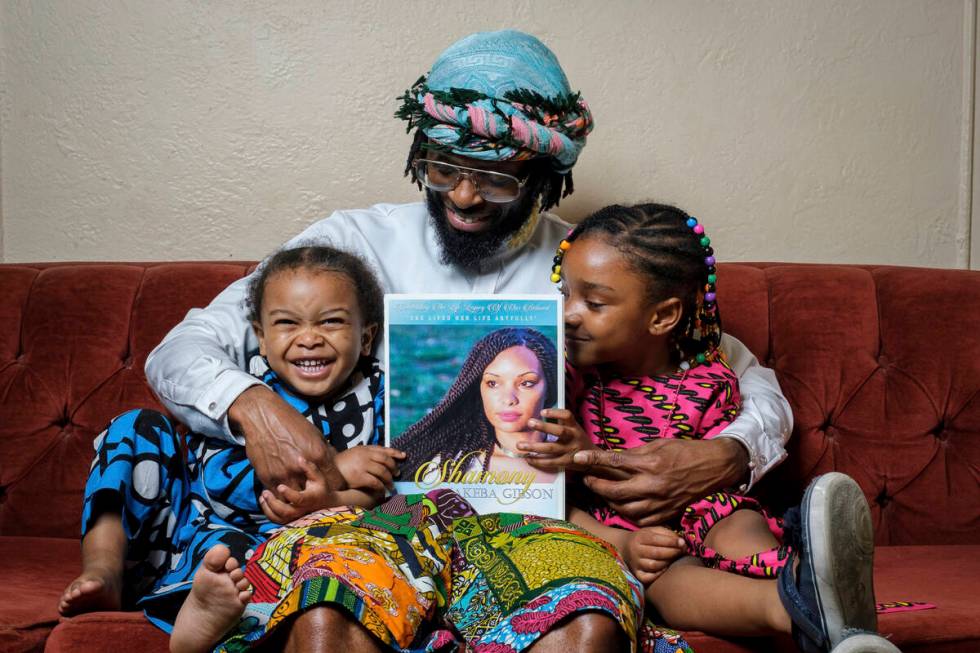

{"left": 384, "top": 295, "right": 565, "bottom": 518}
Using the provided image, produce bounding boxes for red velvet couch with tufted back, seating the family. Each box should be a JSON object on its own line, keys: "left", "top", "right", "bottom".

{"left": 0, "top": 263, "right": 980, "bottom": 653}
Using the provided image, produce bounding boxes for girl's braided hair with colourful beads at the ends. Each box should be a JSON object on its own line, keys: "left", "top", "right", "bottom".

{"left": 555, "top": 203, "right": 721, "bottom": 362}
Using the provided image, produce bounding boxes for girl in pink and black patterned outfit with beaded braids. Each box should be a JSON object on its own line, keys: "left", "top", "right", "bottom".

{"left": 518, "top": 204, "right": 890, "bottom": 651}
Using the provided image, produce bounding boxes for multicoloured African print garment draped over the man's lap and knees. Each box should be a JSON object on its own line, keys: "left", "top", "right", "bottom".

{"left": 217, "top": 490, "right": 652, "bottom": 653}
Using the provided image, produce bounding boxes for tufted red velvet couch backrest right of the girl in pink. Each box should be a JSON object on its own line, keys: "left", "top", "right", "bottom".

{"left": 718, "top": 264, "right": 980, "bottom": 545}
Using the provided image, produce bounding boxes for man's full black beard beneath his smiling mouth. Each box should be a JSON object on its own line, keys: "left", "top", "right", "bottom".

{"left": 425, "top": 188, "right": 538, "bottom": 272}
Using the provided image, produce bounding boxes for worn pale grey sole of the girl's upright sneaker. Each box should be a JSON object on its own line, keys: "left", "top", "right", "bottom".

{"left": 802, "top": 472, "right": 887, "bottom": 650}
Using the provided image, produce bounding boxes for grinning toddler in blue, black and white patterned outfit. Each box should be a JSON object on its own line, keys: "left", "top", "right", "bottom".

{"left": 59, "top": 247, "right": 403, "bottom": 648}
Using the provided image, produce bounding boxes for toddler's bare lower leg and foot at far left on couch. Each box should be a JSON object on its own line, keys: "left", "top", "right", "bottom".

{"left": 58, "top": 511, "right": 128, "bottom": 616}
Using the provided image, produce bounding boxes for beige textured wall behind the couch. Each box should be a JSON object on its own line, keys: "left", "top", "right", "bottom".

{"left": 0, "top": 0, "right": 980, "bottom": 267}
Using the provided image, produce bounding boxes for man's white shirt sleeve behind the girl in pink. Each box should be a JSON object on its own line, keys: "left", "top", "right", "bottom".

{"left": 716, "top": 334, "right": 793, "bottom": 492}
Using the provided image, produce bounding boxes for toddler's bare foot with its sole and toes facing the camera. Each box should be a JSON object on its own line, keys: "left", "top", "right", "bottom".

{"left": 170, "top": 544, "right": 252, "bottom": 653}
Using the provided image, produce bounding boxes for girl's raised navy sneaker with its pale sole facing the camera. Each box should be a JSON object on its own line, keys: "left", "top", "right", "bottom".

{"left": 777, "top": 472, "right": 876, "bottom": 653}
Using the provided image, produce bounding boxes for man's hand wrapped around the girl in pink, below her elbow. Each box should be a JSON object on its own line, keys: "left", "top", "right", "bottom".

{"left": 573, "top": 438, "right": 748, "bottom": 526}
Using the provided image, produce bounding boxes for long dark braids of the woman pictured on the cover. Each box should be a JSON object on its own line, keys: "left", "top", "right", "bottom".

{"left": 394, "top": 327, "right": 558, "bottom": 474}
